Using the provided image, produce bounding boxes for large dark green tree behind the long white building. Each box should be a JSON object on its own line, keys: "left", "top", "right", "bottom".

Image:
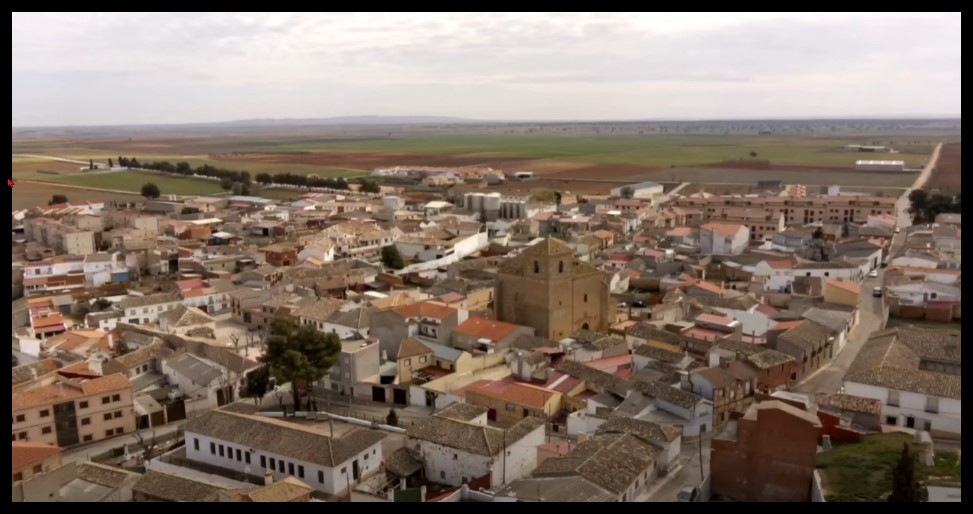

{"left": 260, "top": 318, "right": 341, "bottom": 410}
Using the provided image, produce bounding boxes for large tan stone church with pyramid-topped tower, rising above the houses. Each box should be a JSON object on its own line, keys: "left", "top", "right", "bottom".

{"left": 493, "top": 238, "right": 614, "bottom": 341}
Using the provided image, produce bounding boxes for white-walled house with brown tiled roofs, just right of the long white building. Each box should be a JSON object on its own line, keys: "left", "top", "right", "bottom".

{"left": 406, "top": 404, "right": 545, "bottom": 487}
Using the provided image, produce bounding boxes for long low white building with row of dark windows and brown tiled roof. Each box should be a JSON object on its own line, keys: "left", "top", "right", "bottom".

{"left": 183, "top": 410, "right": 385, "bottom": 496}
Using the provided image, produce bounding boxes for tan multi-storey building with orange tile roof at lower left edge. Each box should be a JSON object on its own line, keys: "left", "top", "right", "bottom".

{"left": 11, "top": 373, "right": 135, "bottom": 448}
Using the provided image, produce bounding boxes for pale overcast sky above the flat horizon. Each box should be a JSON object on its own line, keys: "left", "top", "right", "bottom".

{"left": 13, "top": 12, "right": 960, "bottom": 126}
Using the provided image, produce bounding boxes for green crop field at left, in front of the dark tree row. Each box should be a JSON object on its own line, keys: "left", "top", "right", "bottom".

{"left": 31, "top": 171, "right": 223, "bottom": 195}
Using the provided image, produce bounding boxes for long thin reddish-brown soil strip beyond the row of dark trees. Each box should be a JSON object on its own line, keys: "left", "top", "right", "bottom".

{"left": 211, "top": 152, "right": 536, "bottom": 170}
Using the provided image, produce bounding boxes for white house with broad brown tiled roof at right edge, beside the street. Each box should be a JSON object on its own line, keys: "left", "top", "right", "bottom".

{"left": 844, "top": 328, "right": 962, "bottom": 436}
